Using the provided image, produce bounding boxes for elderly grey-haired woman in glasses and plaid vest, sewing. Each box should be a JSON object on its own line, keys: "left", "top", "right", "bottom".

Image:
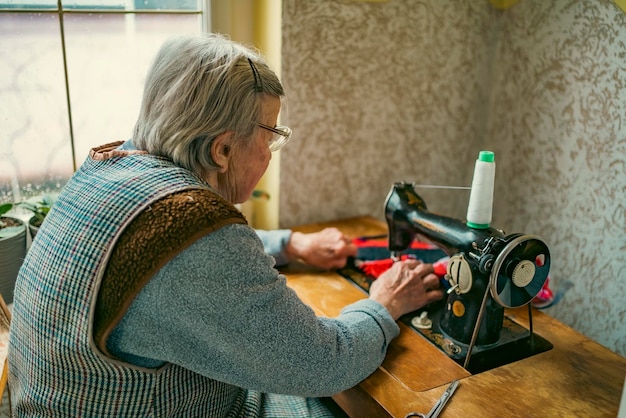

{"left": 9, "top": 35, "right": 442, "bottom": 417}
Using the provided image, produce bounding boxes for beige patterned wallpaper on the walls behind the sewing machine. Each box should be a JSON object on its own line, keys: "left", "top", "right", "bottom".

{"left": 280, "top": 0, "right": 626, "bottom": 355}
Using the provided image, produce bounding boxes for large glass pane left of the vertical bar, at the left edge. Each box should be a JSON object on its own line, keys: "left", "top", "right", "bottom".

{"left": 0, "top": 13, "right": 73, "bottom": 206}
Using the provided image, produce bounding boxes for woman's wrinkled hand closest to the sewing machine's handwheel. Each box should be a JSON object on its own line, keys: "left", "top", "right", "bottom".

{"left": 370, "top": 260, "right": 444, "bottom": 320}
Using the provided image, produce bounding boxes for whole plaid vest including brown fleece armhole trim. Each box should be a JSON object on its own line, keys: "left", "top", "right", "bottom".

{"left": 9, "top": 143, "right": 246, "bottom": 417}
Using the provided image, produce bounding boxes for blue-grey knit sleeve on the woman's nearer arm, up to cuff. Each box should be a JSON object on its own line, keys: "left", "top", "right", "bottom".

{"left": 109, "top": 225, "right": 399, "bottom": 396}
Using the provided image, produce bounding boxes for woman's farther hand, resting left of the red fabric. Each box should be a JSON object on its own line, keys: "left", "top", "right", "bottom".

{"left": 286, "top": 228, "right": 357, "bottom": 270}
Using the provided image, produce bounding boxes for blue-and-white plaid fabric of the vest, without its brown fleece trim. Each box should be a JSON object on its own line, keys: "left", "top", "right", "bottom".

{"left": 9, "top": 145, "right": 261, "bottom": 417}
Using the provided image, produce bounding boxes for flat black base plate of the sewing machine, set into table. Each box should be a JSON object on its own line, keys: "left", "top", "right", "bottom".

{"left": 338, "top": 266, "right": 552, "bottom": 374}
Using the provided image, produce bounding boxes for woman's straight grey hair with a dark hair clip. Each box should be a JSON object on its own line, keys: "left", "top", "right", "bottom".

{"left": 133, "top": 34, "right": 285, "bottom": 175}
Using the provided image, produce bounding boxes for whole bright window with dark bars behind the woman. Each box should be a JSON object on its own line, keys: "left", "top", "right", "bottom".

{"left": 0, "top": 0, "right": 208, "bottom": 203}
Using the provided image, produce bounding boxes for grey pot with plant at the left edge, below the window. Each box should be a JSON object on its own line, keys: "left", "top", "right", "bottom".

{"left": 0, "top": 203, "right": 26, "bottom": 303}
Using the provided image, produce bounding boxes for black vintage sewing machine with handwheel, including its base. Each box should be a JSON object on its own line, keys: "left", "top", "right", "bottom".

{"left": 385, "top": 182, "right": 552, "bottom": 373}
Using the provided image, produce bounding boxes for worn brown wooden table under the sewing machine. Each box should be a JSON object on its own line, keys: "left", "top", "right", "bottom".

{"left": 285, "top": 217, "right": 626, "bottom": 418}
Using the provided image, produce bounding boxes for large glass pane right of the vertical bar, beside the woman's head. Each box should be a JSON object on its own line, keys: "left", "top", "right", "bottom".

{"left": 65, "top": 14, "right": 200, "bottom": 165}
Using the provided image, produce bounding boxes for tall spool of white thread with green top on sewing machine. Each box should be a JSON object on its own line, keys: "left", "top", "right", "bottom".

{"left": 467, "top": 151, "right": 496, "bottom": 229}
